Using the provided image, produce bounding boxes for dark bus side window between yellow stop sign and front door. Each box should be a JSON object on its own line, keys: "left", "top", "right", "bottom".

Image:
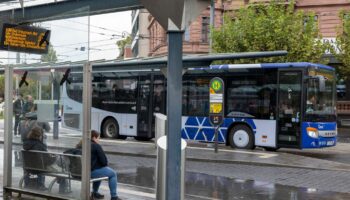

{"left": 226, "top": 70, "right": 277, "bottom": 119}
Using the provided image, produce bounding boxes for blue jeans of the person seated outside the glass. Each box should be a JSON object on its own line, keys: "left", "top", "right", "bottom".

{"left": 91, "top": 167, "right": 117, "bottom": 197}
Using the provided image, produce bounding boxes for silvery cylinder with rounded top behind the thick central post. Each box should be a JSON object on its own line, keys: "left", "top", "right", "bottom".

{"left": 155, "top": 136, "right": 187, "bottom": 200}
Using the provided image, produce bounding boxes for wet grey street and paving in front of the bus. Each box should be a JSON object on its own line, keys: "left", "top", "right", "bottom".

{"left": 0, "top": 123, "right": 350, "bottom": 200}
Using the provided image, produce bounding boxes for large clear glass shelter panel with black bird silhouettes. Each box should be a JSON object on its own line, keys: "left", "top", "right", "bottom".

{"left": 7, "top": 8, "right": 89, "bottom": 199}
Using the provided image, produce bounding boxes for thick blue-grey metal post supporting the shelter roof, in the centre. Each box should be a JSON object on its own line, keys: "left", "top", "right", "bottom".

{"left": 166, "top": 30, "right": 183, "bottom": 200}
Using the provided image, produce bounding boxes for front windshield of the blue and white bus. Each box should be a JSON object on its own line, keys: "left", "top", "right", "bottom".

{"left": 305, "top": 70, "right": 335, "bottom": 120}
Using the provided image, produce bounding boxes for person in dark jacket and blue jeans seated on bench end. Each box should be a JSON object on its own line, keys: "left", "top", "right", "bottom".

{"left": 77, "top": 130, "right": 121, "bottom": 200}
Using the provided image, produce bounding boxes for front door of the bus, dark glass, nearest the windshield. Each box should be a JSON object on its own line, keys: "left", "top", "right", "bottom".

{"left": 277, "top": 70, "right": 302, "bottom": 148}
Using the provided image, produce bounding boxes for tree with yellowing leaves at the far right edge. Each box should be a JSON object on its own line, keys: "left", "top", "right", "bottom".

{"left": 333, "top": 12, "right": 350, "bottom": 79}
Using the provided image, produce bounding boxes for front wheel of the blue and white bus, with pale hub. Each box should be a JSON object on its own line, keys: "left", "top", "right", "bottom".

{"left": 229, "top": 125, "right": 254, "bottom": 149}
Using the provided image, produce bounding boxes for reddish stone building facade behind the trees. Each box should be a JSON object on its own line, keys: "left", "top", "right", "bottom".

{"left": 134, "top": 0, "right": 350, "bottom": 56}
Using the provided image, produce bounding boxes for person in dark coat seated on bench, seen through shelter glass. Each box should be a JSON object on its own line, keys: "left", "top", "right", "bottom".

{"left": 23, "top": 126, "right": 47, "bottom": 190}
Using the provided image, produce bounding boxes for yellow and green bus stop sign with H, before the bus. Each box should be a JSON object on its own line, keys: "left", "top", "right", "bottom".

{"left": 209, "top": 77, "right": 224, "bottom": 126}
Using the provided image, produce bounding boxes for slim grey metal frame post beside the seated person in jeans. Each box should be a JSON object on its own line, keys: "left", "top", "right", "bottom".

{"left": 81, "top": 62, "right": 92, "bottom": 199}
